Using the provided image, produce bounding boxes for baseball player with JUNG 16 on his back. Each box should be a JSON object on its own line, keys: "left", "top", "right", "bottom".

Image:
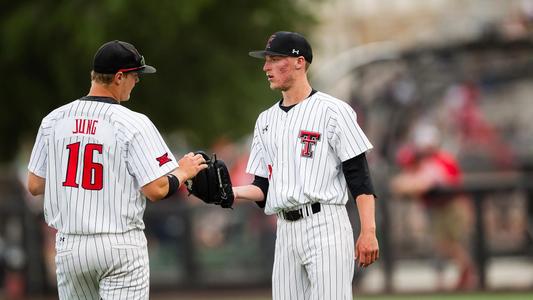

{"left": 28, "top": 41, "right": 206, "bottom": 299}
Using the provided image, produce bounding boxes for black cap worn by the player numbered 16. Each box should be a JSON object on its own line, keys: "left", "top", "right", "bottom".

{"left": 93, "top": 40, "right": 156, "bottom": 74}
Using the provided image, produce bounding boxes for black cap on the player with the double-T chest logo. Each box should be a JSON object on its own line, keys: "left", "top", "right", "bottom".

{"left": 248, "top": 31, "right": 313, "bottom": 63}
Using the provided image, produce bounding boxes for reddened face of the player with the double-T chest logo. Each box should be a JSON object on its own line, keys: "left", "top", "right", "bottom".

{"left": 263, "top": 55, "right": 297, "bottom": 91}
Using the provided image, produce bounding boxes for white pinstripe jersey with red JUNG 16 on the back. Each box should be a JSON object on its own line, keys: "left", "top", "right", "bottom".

{"left": 28, "top": 97, "right": 178, "bottom": 234}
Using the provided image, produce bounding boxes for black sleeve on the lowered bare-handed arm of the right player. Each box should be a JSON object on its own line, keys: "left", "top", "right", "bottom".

{"left": 342, "top": 153, "right": 375, "bottom": 199}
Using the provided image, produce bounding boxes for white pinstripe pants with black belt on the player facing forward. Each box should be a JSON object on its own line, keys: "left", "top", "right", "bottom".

{"left": 272, "top": 205, "right": 355, "bottom": 300}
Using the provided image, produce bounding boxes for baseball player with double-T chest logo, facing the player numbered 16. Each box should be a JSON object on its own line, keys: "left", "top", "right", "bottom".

{"left": 234, "top": 31, "right": 379, "bottom": 299}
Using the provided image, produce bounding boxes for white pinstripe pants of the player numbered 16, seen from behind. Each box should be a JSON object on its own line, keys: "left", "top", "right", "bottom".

{"left": 56, "top": 230, "right": 150, "bottom": 300}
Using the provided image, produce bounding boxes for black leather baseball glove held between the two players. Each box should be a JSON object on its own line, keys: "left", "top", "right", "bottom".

{"left": 185, "top": 151, "right": 235, "bottom": 208}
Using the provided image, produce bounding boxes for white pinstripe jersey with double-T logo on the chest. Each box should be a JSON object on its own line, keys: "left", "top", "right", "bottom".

{"left": 246, "top": 92, "right": 372, "bottom": 214}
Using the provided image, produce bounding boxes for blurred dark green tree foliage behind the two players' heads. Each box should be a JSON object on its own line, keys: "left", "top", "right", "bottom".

{"left": 0, "top": 0, "right": 319, "bottom": 163}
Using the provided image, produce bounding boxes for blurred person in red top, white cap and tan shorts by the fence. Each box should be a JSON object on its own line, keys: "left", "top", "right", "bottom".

{"left": 391, "top": 124, "right": 477, "bottom": 290}
